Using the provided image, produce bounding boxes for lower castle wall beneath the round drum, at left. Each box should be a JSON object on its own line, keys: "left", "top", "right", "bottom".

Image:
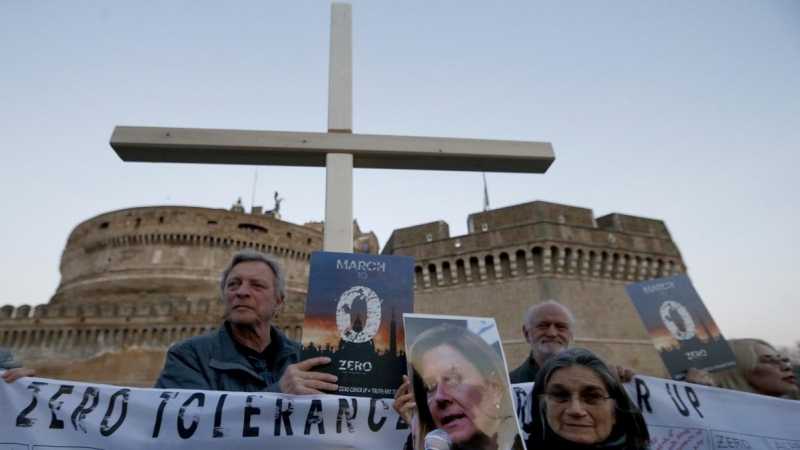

{"left": 0, "top": 299, "right": 305, "bottom": 387}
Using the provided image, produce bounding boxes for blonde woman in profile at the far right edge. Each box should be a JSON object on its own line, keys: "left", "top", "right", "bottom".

{"left": 708, "top": 339, "right": 798, "bottom": 397}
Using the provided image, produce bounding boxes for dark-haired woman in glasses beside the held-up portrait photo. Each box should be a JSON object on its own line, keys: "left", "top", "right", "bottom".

{"left": 524, "top": 348, "right": 650, "bottom": 450}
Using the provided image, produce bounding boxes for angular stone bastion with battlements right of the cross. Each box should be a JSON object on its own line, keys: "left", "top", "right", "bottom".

{"left": 382, "top": 201, "right": 685, "bottom": 376}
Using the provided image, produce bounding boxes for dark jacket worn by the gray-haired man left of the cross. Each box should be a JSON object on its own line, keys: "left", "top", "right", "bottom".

{"left": 155, "top": 324, "right": 300, "bottom": 392}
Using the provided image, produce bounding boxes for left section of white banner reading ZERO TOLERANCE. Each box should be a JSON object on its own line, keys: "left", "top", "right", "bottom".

{"left": 0, "top": 372, "right": 409, "bottom": 450}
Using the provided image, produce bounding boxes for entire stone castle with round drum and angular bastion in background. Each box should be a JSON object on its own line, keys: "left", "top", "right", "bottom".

{"left": 0, "top": 202, "right": 685, "bottom": 387}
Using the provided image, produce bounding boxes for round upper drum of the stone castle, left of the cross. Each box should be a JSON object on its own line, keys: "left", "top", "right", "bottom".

{"left": 50, "top": 204, "right": 322, "bottom": 304}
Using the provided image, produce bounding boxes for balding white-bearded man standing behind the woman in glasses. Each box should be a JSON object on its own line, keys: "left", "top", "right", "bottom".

{"left": 508, "top": 299, "right": 634, "bottom": 383}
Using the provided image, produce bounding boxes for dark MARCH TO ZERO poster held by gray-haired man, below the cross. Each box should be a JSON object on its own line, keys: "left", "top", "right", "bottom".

{"left": 300, "top": 252, "right": 414, "bottom": 398}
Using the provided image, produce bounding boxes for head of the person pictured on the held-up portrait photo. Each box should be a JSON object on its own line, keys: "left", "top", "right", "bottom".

{"left": 409, "top": 325, "right": 523, "bottom": 450}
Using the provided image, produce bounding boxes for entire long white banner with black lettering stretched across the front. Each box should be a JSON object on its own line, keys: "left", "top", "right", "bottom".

{"left": 0, "top": 377, "right": 800, "bottom": 450}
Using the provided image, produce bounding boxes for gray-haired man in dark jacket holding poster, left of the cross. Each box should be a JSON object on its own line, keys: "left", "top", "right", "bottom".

{"left": 155, "top": 249, "right": 338, "bottom": 394}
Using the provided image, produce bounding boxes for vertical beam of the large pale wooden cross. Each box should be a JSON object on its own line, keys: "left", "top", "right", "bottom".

{"left": 323, "top": 3, "right": 353, "bottom": 253}
